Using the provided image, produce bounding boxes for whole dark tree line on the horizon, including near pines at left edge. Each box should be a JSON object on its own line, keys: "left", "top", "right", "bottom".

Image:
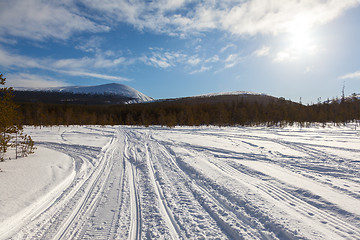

{"left": 0, "top": 69, "right": 360, "bottom": 165}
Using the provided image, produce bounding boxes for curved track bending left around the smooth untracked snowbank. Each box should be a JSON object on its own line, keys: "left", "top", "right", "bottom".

{"left": 4, "top": 142, "right": 108, "bottom": 239}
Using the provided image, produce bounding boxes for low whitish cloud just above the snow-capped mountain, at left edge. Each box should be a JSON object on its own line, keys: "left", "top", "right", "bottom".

{"left": 6, "top": 73, "right": 68, "bottom": 88}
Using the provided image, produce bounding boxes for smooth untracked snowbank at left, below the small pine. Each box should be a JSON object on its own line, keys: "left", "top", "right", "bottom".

{"left": 0, "top": 147, "right": 75, "bottom": 238}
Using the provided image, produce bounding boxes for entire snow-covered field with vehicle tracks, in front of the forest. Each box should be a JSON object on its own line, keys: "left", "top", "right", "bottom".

{"left": 0, "top": 126, "right": 360, "bottom": 239}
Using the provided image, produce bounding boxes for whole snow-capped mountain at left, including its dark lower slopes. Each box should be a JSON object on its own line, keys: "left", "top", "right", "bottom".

{"left": 15, "top": 83, "right": 153, "bottom": 104}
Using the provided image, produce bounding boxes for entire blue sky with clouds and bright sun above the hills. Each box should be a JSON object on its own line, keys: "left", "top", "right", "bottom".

{"left": 0, "top": 0, "right": 360, "bottom": 103}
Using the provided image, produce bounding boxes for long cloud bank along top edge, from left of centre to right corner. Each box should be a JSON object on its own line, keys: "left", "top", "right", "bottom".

{"left": 82, "top": 0, "right": 359, "bottom": 36}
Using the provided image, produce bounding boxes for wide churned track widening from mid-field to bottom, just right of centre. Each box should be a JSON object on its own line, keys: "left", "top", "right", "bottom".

{"left": 149, "top": 135, "right": 233, "bottom": 239}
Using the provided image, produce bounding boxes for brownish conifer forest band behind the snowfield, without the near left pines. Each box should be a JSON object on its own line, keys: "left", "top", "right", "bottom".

{"left": 17, "top": 92, "right": 360, "bottom": 127}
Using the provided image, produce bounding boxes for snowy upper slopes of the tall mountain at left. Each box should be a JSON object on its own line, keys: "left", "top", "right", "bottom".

{"left": 15, "top": 83, "right": 153, "bottom": 103}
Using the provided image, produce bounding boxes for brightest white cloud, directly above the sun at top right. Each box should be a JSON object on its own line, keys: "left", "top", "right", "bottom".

{"left": 221, "top": 0, "right": 359, "bottom": 35}
